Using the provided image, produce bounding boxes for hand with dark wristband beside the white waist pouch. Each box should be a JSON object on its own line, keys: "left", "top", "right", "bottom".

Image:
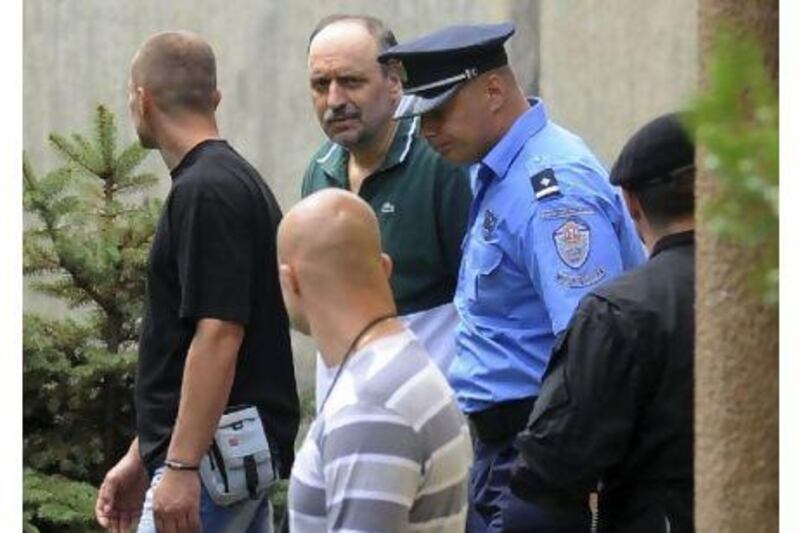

{"left": 153, "top": 468, "right": 200, "bottom": 533}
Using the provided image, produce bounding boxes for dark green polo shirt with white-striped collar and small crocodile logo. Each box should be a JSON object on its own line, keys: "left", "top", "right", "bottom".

{"left": 302, "top": 118, "right": 472, "bottom": 315}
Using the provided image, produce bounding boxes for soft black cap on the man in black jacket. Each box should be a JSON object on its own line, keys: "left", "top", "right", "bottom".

{"left": 610, "top": 113, "right": 694, "bottom": 189}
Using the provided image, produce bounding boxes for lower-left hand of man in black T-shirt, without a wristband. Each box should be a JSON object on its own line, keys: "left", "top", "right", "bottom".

{"left": 94, "top": 441, "right": 150, "bottom": 533}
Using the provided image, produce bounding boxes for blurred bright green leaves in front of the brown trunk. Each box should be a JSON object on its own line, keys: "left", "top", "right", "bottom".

{"left": 689, "top": 30, "right": 779, "bottom": 304}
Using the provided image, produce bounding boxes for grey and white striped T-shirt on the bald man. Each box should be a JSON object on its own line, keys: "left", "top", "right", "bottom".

{"left": 289, "top": 332, "right": 472, "bottom": 533}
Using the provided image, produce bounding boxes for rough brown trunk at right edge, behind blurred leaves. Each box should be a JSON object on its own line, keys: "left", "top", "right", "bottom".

{"left": 695, "top": 0, "right": 778, "bottom": 532}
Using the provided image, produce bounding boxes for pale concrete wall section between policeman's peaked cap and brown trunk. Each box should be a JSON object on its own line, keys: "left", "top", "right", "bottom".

{"left": 539, "top": 0, "right": 698, "bottom": 165}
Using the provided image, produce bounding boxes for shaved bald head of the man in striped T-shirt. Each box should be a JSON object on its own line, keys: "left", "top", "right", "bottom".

{"left": 278, "top": 189, "right": 394, "bottom": 333}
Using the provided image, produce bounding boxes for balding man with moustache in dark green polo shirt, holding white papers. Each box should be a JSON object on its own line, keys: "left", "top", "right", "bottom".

{"left": 302, "top": 15, "right": 472, "bottom": 405}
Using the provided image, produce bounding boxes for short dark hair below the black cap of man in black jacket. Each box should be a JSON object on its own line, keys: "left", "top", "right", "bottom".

{"left": 623, "top": 165, "right": 695, "bottom": 227}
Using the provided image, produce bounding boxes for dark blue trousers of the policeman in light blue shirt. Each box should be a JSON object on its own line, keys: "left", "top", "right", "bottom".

{"left": 467, "top": 437, "right": 591, "bottom": 533}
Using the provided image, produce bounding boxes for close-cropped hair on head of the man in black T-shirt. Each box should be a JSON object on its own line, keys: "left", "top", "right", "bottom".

{"left": 131, "top": 31, "right": 219, "bottom": 113}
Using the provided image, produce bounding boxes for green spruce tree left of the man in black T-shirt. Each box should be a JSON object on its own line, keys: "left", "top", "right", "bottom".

{"left": 23, "top": 106, "right": 161, "bottom": 531}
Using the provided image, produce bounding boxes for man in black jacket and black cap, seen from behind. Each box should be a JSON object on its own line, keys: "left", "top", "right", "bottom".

{"left": 504, "top": 115, "right": 695, "bottom": 533}
